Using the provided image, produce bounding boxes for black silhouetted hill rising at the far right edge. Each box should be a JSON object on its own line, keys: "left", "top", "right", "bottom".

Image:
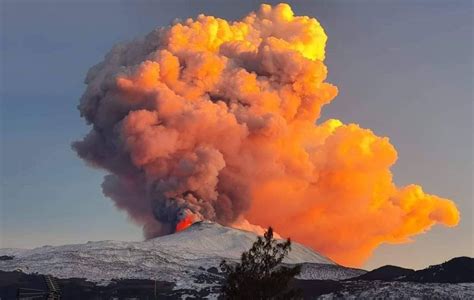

{"left": 402, "top": 256, "right": 474, "bottom": 283}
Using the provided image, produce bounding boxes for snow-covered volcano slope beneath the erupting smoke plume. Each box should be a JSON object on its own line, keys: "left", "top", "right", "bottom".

{"left": 0, "top": 222, "right": 352, "bottom": 288}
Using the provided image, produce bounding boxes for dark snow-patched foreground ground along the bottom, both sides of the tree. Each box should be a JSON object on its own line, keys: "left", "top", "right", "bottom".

{"left": 0, "top": 271, "right": 474, "bottom": 300}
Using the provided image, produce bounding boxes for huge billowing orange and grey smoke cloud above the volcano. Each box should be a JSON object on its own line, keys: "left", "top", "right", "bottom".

{"left": 73, "top": 4, "right": 459, "bottom": 265}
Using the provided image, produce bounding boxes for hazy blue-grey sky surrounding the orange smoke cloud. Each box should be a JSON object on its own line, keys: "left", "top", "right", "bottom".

{"left": 0, "top": 0, "right": 474, "bottom": 269}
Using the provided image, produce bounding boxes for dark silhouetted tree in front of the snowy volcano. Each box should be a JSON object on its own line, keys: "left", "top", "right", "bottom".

{"left": 221, "top": 227, "right": 301, "bottom": 299}
